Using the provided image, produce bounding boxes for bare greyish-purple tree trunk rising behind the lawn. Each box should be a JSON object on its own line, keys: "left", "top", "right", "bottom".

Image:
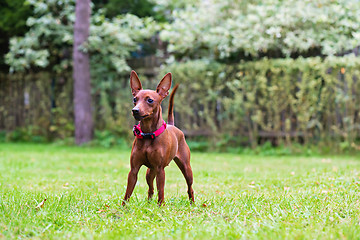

{"left": 73, "top": 0, "right": 94, "bottom": 145}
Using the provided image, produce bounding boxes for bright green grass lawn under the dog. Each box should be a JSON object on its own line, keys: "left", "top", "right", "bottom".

{"left": 0, "top": 144, "right": 360, "bottom": 239}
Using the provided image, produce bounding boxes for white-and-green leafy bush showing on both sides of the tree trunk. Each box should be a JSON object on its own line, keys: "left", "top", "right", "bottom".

{"left": 6, "top": 0, "right": 157, "bottom": 74}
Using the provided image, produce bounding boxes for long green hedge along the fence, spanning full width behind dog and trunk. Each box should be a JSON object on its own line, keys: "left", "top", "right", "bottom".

{"left": 0, "top": 56, "right": 360, "bottom": 148}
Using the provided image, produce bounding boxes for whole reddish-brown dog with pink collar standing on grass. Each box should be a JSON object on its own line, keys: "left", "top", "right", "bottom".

{"left": 123, "top": 71, "right": 194, "bottom": 205}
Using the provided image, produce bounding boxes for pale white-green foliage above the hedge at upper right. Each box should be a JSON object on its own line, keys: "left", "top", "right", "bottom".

{"left": 161, "top": 0, "right": 360, "bottom": 59}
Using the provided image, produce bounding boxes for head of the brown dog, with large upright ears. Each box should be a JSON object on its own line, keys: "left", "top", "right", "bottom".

{"left": 130, "top": 71, "right": 171, "bottom": 121}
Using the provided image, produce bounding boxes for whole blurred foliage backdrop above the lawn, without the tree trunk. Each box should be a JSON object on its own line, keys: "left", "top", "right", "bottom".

{"left": 0, "top": 0, "right": 360, "bottom": 152}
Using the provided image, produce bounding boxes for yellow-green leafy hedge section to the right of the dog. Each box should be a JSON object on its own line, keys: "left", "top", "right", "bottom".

{"left": 159, "top": 56, "right": 360, "bottom": 147}
